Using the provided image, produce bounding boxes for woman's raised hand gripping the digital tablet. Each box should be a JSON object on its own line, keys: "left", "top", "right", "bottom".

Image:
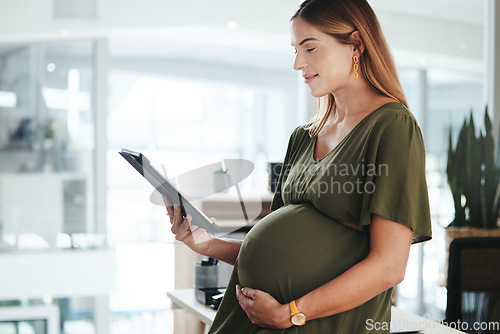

{"left": 163, "top": 196, "right": 215, "bottom": 255}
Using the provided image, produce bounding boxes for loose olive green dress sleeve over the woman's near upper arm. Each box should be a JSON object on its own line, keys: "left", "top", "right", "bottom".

{"left": 360, "top": 112, "right": 432, "bottom": 243}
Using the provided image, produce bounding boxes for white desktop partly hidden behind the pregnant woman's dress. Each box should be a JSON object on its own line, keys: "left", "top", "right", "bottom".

{"left": 167, "top": 289, "right": 463, "bottom": 334}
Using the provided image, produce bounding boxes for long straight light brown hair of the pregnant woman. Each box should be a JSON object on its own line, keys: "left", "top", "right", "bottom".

{"left": 291, "top": 0, "right": 408, "bottom": 137}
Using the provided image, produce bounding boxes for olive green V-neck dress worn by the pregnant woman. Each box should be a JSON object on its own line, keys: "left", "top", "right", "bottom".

{"left": 209, "top": 102, "right": 431, "bottom": 334}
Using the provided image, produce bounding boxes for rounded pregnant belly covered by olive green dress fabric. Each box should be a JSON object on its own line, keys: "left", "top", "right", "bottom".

{"left": 235, "top": 204, "right": 369, "bottom": 303}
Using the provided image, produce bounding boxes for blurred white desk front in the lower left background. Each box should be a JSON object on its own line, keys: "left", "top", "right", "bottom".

{"left": 0, "top": 248, "right": 116, "bottom": 300}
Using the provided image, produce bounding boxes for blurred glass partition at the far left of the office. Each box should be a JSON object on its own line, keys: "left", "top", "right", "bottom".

{"left": 0, "top": 40, "right": 95, "bottom": 249}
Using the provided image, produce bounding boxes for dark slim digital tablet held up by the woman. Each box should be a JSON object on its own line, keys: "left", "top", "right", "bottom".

{"left": 119, "top": 149, "right": 222, "bottom": 234}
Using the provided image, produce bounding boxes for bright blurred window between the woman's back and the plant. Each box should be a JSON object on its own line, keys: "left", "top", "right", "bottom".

{"left": 398, "top": 69, "right": 484, "bottom": 319}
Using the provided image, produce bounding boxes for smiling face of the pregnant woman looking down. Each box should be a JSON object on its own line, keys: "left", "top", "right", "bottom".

{"left": 291, "top": 17, "right": 356, "bottom": 97}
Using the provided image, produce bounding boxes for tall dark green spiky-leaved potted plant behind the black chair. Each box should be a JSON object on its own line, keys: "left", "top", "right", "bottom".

{"left": 446, "top": 107, "right": 500, "bottom": 242}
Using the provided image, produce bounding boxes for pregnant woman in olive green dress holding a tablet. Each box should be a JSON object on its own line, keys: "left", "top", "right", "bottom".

{"left": 165, "top": 0, "right": 431, "bottom": 334}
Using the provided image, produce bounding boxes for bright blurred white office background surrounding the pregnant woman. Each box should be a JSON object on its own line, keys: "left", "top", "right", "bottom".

{"left": 0, "top": 0, "right": 490, "bottom": 334}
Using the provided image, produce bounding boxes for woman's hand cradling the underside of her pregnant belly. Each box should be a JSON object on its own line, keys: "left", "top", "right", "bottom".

{"left": 236, "top": 285, "right": 292, "bottom": 329}
